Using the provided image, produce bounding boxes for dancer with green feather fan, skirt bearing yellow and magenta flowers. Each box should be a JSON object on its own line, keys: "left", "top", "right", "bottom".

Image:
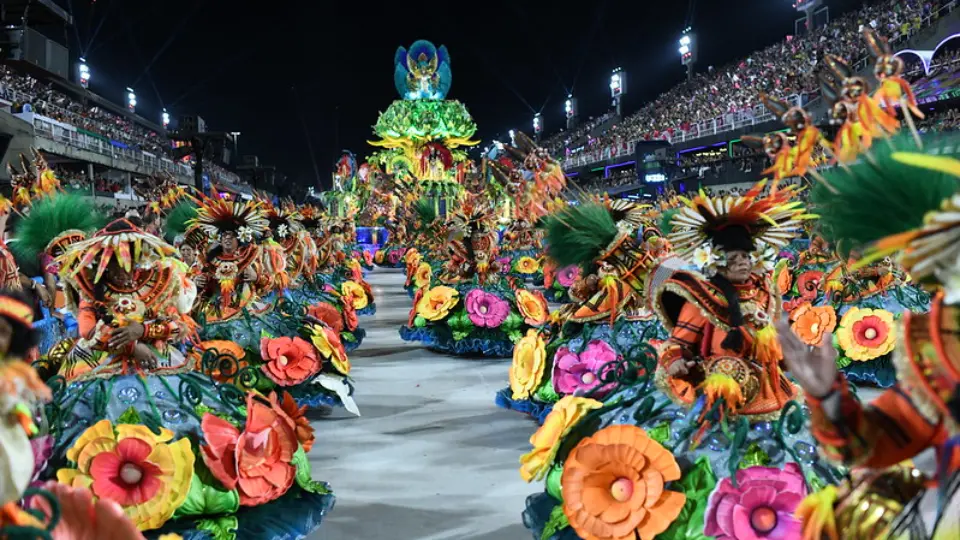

{"left": 496, "top": 196, "right": 670, "bottom": 423}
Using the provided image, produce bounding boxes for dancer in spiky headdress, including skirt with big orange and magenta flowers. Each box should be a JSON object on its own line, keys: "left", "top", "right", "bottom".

{"left": 521, "top": 185, "right": 839, "bottom": 539}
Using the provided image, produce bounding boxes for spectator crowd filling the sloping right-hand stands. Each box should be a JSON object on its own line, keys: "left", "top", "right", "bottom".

{"left": 543, "top": 0, "right": 956, "bottom": 165}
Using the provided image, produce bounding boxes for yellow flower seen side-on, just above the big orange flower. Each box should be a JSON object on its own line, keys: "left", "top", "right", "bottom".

{"left": 520, "top": 395, "right": 603, "bottom": 482}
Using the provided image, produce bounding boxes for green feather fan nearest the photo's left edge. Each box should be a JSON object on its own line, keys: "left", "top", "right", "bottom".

{"left": 10, "top": 193, "right": 107, "bottom": 260}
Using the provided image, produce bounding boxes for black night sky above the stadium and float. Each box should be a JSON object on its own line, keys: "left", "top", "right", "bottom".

{"left": 63, "top": 0, "right": 861, "bottom": 189}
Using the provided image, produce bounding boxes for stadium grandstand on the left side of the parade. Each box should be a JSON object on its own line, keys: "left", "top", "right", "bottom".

{"left": 0, "top": 0, "right": 262, "bottom": 211}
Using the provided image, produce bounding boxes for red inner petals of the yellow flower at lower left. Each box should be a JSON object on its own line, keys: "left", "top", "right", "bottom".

{"left": 90, "top": 438, "right": 163, "bottom": 506}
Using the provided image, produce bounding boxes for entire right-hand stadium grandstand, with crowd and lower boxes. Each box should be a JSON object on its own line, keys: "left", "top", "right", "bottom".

{"left": 541, "top": 0, "right": 960, "bottom": 198}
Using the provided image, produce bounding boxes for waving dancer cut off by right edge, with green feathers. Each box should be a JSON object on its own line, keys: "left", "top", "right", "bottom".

{"left": 781, "top": 135, "right": 960, "bottom": 538}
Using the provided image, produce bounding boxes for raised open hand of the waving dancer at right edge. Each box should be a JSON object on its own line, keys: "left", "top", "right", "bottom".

{"left": 777, "top": 320, "right": 838, "bottom": 399}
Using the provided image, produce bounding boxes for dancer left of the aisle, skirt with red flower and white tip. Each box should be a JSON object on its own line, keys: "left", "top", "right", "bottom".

{"left": 191, "top": 197, "right": 359, "bottom": 414}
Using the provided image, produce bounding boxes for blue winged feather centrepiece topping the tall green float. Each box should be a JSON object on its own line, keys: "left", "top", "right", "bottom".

{"left": 393, "top": 39, "right": 453, "bottom": 99}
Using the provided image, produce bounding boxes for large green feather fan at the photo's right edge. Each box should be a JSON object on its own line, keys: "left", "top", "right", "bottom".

{"left": 810, "top": 135, "right": 960, "bottom": 254}
